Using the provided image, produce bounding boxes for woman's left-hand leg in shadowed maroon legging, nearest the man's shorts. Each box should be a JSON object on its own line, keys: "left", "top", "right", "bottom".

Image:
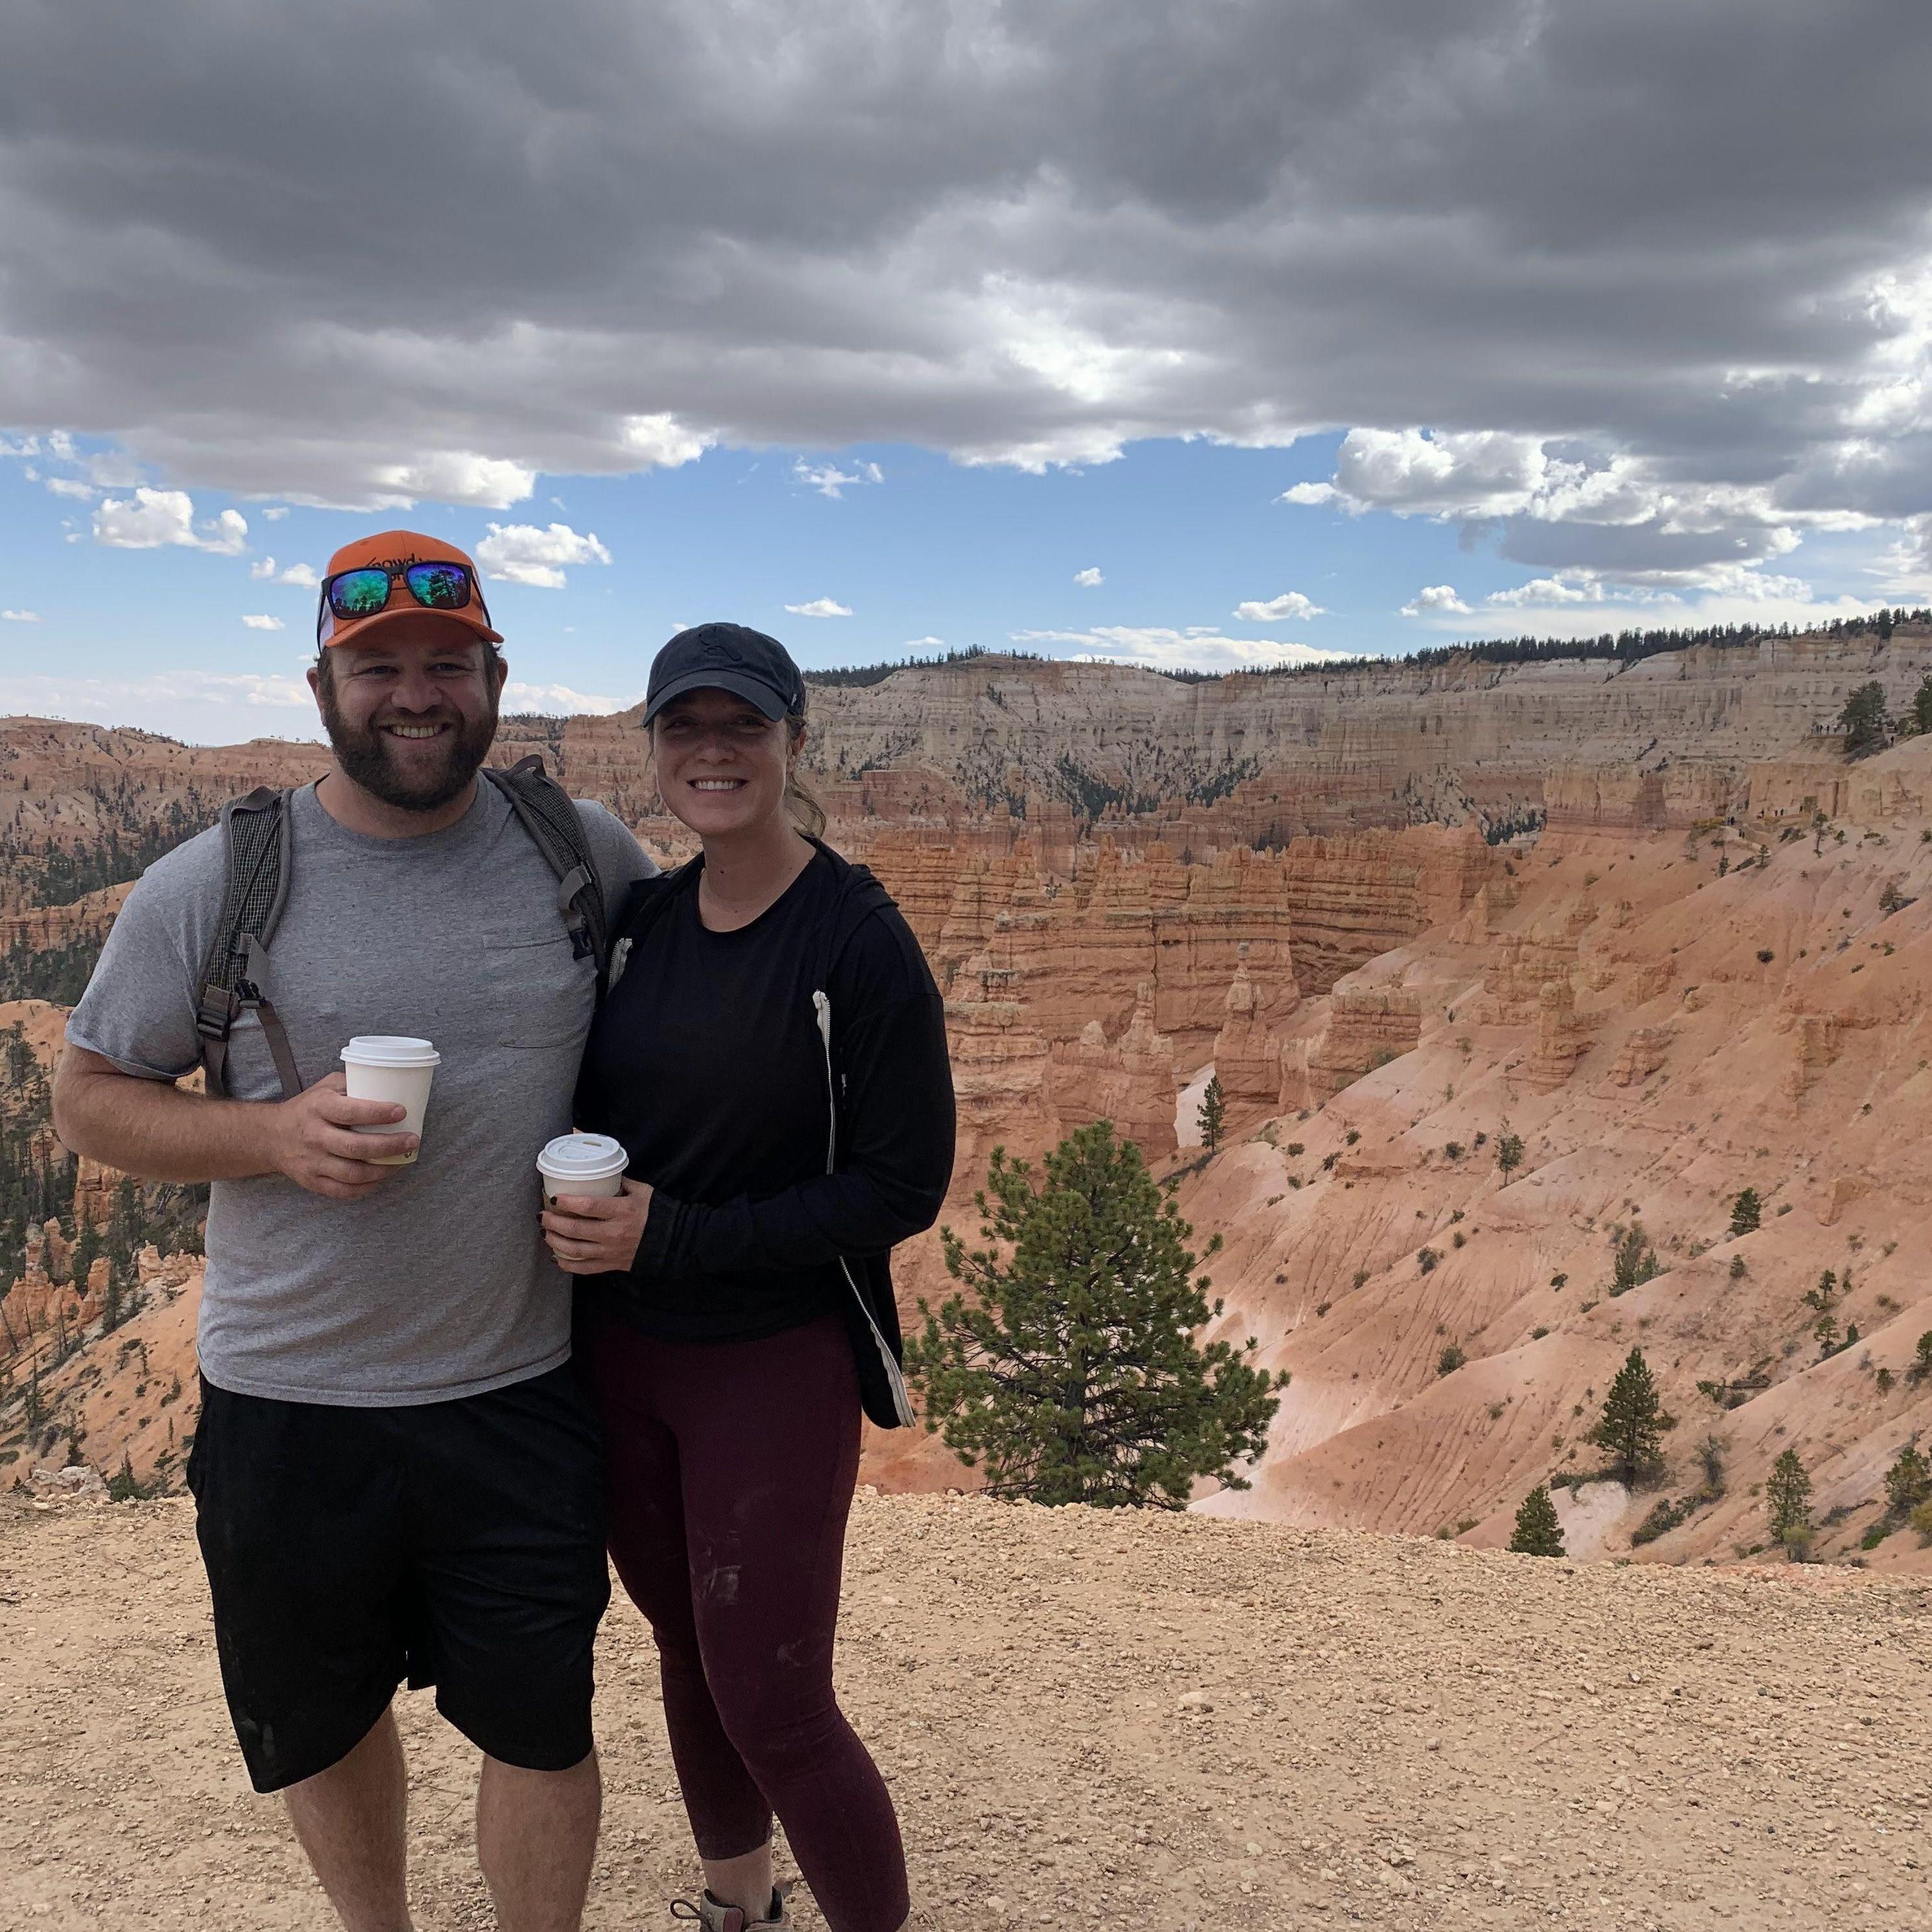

{"left": 578, "top": 1320, "right": 771, "bottom": 1870}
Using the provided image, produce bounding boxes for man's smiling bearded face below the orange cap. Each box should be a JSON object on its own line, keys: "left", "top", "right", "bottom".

{"left": 309, "top": 612, "right": 505, "bottom": 811}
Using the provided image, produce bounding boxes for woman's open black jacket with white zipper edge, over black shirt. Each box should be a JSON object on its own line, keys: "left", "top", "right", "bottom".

{"left": 578, "top": 844, "right": 955, "bottom": 1427}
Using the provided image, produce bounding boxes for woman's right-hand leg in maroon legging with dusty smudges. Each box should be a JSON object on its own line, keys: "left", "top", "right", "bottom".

{"left": 663, "top": 1316, "right": 906, "bottom": 1932}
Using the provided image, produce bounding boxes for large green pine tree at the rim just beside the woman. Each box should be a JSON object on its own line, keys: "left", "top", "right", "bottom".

{"left": 906, "top": 1121, "right": 1289, "bottom": 1509}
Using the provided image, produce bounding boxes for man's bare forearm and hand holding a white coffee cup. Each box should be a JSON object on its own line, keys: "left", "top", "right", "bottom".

{"left": 54, "top": 1042, "right": 417, "bottom": 1200}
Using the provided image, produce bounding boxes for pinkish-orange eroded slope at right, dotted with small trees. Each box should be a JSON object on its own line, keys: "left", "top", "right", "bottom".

{"left": 1180, "top": 742, "right": 1932, "bottom": 1569}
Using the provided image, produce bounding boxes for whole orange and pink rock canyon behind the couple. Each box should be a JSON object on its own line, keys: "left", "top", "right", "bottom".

{"left": 0, "top": 626, "right": 1932, "bottom": 1575}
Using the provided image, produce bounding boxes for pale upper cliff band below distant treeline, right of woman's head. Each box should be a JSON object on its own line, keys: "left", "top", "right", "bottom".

{"left": 784, "top": 630, "right": 1932, "bottom": 827}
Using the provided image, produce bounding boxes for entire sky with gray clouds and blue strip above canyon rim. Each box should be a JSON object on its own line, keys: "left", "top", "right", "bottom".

{"left": 0, "top": 0, "right": 1932, "bottom": 740}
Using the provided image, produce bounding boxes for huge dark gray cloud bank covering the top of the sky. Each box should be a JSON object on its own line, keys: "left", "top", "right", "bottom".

{"left": 0, "top": 0, "right": 1932, "bottom": 582}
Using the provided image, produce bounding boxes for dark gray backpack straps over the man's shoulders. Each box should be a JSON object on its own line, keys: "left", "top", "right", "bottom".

{"left": 195, "top": 756, "right": 610, "bottom": 1099}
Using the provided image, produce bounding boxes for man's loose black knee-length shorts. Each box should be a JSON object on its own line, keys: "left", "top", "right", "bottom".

{"left": 187, "top": 1368, "right": 610, "bottom": 1791}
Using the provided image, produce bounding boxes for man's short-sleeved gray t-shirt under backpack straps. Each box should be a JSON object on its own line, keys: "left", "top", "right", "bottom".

{"left": 67, "top": 784, "right": 655, "bottom": 1409}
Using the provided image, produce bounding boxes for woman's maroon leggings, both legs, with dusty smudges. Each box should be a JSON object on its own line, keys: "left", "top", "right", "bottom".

{"left": 578, "top": 1316, "right": 906, "bottom": 1932}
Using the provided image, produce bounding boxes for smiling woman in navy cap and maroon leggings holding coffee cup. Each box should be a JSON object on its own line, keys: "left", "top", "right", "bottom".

{"left": 543, "top": 624, "right": 953, "bottom": 1932}
